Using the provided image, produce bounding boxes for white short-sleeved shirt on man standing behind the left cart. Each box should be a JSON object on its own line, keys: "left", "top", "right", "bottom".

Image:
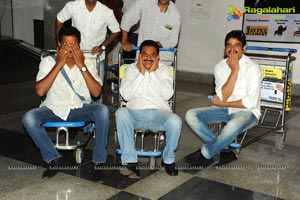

{"left": 57, "top": 0, "right": 120, "bottom": 60}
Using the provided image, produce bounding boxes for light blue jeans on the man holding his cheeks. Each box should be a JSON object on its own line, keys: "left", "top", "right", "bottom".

{"left": 115, "top": 108, "right": 182, "bottom": 164}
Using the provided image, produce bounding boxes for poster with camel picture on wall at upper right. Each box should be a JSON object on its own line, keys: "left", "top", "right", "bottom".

{"left": 243, "top": 0, "right": 300, "bottom": 43}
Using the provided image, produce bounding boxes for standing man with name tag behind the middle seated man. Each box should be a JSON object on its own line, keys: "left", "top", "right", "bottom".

{"left": 121, "top": 0, "right": 181, "bottom": 61}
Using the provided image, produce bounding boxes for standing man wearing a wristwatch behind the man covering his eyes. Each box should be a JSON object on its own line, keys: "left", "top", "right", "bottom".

{"left": 55, "top": 0, "right": 120, "bottom": 90}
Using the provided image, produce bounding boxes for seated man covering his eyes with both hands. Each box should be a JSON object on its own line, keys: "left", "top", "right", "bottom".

{"left": 22, "top": 27, "right": 109, "bottom": 180}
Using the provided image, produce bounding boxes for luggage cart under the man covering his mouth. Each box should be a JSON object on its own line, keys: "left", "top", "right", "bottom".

{"left": 240, "top": 46, "right": 297, "bottom": 149}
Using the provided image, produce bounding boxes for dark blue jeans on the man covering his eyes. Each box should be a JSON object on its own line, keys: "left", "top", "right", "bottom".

{"left": 22, "top": 104, "right": 109, "bottom": 163}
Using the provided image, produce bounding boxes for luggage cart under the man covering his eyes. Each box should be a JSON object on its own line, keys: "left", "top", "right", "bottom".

{"left": 41, "top": 50, "right": 100, "bottom": 164}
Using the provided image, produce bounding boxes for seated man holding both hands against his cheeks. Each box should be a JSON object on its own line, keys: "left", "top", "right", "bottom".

{"left": 115, "top": 40, "right": 182, "bottom": 177}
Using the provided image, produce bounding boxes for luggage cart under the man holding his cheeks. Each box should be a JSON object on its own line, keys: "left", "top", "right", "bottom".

{"left": 115, "top": 46, "right": 177, "bottom": 167}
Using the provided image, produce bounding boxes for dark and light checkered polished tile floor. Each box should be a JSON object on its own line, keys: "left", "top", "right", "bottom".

{"left": 0, "top": 78, "right": 300, "bottom": 200}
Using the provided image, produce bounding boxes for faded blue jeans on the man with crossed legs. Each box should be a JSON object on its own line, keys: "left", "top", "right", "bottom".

{"left": 185, "top": 106, "right": 258, "bottom": 159}
